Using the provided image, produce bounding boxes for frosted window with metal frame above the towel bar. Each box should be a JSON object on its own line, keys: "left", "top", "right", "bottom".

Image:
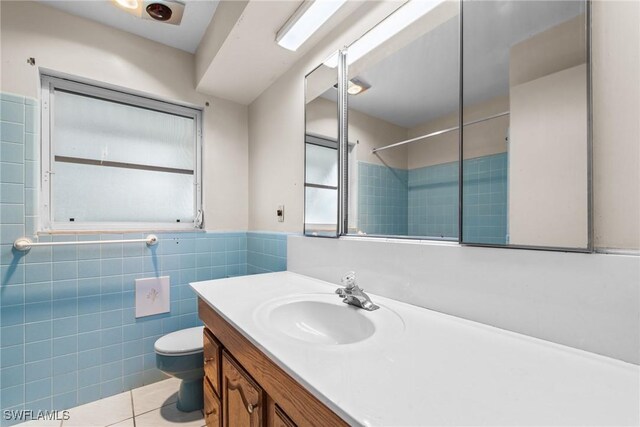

{"left": 41, "top": 76, "right": 202, "bottom": 230}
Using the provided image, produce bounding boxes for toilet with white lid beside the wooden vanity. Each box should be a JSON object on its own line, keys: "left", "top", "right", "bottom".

{"left": 154, "top": 326, "right": 204, "bottom": 412}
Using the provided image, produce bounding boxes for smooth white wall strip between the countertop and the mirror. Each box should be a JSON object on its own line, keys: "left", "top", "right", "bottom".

{"left": 287, "top": 236, "right": 640, "bottom": 364}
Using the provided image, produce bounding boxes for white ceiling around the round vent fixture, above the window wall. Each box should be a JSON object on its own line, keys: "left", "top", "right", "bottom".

{"left": 39, "top": 0, "right": 218, "bottom": 53}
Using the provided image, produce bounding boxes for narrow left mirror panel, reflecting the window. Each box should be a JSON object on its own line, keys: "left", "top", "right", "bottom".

{"left": 304, "top": 64, "right": 338, "bottom": 237}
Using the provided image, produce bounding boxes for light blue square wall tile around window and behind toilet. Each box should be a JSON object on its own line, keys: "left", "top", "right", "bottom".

{"left": 0, "top": 94, "right": 286, "bottom": 425}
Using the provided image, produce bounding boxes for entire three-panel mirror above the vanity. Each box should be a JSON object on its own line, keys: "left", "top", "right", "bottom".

{"left": 305, "top": 0, "right": 591, "bottom": 251}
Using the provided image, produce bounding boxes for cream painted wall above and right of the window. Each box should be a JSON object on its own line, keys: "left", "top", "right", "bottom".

{"left": 0, "top": 0, "right": 248, "bottom": 230}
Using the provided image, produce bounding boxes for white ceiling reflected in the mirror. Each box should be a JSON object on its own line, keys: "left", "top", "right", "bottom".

{"left": 323, "top": 0, "right": 584, "bottom": 128}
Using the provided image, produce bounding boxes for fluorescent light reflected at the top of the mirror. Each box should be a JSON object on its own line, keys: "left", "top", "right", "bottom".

{"left": 324, "top": 0, "right": 445, "bottom": 68}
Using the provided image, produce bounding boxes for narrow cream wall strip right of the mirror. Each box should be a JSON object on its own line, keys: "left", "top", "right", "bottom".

{"left": 592, "top": 1, "right": 640, "bottom": 250}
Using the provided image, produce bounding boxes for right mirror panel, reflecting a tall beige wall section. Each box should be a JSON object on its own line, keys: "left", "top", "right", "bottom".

{"left": 462, "top": 0, "right": 590, "bottom": 249}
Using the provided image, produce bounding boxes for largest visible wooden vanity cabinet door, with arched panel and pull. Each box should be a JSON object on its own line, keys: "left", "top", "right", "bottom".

{"left": 222, "top": 351, "right": 265, "bottom": 427}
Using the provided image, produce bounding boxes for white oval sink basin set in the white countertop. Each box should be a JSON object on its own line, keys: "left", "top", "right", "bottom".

{"left": 256, "top": 294, "right": 404, "bottom": 345}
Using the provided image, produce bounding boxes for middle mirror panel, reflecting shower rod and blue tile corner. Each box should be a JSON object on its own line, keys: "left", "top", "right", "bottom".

{"left": 346, "top": 1, "right": 460, "bottom": 241}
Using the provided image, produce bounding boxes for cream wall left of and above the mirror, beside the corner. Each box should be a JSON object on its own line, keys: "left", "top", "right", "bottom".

{"left": 249, "top": 1, "right": 400, "bottom": 232}
